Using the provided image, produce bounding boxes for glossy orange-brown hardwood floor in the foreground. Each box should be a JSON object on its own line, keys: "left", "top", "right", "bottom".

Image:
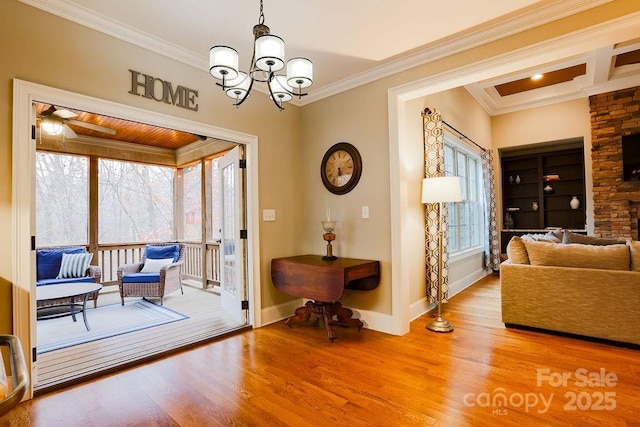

{"left": 0, "top": 276, "right": 640, "bottom": 426}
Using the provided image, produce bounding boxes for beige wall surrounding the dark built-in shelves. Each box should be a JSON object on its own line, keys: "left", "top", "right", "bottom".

{"left": 491, "top": 97, "right": 593, "bottom": 234}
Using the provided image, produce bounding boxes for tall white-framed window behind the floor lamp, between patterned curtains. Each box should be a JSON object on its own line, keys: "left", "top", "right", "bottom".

{"left": 444, "top": 135, "right": 483, "bottom": 253}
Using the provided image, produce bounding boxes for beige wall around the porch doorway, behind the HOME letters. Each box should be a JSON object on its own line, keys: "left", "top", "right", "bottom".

{"left": 0, "top": 0, "right": 303, "bottom": 333}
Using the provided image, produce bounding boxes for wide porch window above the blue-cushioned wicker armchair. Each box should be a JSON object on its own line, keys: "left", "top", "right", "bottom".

{"left": 98, "top": 159, "right": 175, "bottom": 244}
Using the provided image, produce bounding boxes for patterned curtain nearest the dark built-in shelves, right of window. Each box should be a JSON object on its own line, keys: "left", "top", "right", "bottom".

{"left": 480, "top": 150, "right": 500, "bottom": 271}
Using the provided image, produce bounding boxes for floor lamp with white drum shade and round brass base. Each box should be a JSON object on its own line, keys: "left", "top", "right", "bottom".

{"left": 422, "top": 176, "right": 462, "bottom": 332}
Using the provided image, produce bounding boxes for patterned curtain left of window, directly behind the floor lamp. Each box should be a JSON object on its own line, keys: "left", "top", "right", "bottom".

{"left": 422, "top": 108, "right": 449, "bottom": 304}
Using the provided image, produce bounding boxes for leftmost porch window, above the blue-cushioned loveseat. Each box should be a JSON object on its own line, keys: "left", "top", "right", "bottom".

{"left": 36, "top": 151, "right": 89, "bottom": 247}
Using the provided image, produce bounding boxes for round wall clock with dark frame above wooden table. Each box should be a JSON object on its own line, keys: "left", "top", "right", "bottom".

{"left": 320, "top": 142, "right": 362, "bottom": 194}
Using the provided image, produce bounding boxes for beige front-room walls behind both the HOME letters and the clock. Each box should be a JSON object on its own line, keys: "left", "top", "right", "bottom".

{"left": 0, "top": 0, "right": 638, "bottom": 332}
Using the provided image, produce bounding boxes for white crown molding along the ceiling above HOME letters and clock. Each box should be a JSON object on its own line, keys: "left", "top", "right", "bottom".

{"left": 19, "top": 0, "right": 613, "bottom": 106}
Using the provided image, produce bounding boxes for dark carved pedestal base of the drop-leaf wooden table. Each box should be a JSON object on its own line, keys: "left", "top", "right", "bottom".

{"left": 285, "top": 301, "right": 364, "bottom": 341}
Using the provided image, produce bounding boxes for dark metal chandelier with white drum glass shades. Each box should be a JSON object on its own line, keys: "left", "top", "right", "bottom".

{"left": 209, "top": 0, "right": 313, "bottom": 110}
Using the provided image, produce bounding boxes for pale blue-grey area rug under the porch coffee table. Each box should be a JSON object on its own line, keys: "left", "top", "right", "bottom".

{"left": 37, "top": 299, "right": 189, "bottom": 354}
